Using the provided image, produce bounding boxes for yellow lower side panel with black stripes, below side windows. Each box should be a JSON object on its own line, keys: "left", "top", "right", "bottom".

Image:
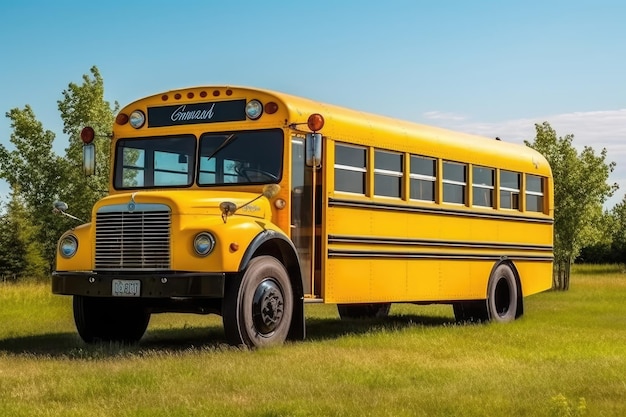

{"left": 324, "top": 200, "right": 552, "bottom": 303}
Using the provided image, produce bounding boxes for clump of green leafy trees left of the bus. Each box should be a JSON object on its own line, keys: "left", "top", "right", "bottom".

{"left": 0, "top": 67, "right": 118, "bottom": 271}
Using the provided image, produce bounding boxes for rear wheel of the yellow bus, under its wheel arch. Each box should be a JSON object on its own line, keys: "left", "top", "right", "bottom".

{"left": 487, "top": 264, "right": 521, "bottom": 323}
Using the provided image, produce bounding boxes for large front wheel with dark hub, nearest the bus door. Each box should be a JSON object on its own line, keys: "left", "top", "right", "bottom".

{"left": 222, "top": 256, "right": 293, "bottom": 348}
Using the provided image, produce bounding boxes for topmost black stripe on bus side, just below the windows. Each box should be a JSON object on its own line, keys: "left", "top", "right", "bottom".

{"left": 328, "top": 198, "right": 554, "bottom": 224}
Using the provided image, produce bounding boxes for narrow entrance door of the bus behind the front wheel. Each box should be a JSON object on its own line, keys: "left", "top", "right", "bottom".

{"left": 291, "top": 135, "right": 319, "bottom": 296}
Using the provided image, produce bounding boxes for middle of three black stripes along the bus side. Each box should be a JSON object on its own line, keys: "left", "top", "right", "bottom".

{"left": 328, "top": 235, "right": 553, "bottom": 252}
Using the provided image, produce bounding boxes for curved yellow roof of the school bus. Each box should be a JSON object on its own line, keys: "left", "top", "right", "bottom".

{"left": 122, "top": 85, "right": 551, "bottom": 176}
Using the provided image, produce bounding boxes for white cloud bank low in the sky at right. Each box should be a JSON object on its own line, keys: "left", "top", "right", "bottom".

{"left": 424, "top": 109, "right": 626, "bottom": 208}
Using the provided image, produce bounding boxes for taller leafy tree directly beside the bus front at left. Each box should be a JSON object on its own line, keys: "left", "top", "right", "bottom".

{"left": 57, "top": 66, "right": 119, "bottom": 220}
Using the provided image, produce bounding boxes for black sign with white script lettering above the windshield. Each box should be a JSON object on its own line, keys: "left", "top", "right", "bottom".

{"left": 148, "top": 100, "right": 246, "bottom": 127}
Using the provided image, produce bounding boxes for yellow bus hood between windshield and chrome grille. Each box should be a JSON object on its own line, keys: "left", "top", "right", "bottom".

{"left": 92, "top": 190, "right": 271, "bottom": 218}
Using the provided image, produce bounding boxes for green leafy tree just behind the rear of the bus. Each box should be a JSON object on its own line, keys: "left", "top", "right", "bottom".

{"left": 525, "top": 122, "right": 617, "bottom": 290}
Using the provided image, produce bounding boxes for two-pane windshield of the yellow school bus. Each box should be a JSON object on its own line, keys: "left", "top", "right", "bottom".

{"left": 115, "top": 129, "right": 283, "bottom": 189}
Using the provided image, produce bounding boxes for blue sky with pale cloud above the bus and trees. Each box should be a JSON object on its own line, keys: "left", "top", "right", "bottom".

{"left": 0, "top": 0, "right": 626, "bottom": 206}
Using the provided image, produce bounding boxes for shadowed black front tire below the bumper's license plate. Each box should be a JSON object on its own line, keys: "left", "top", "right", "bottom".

{"left": 73, "top": 295, "right": 150, "bottom": 343}
